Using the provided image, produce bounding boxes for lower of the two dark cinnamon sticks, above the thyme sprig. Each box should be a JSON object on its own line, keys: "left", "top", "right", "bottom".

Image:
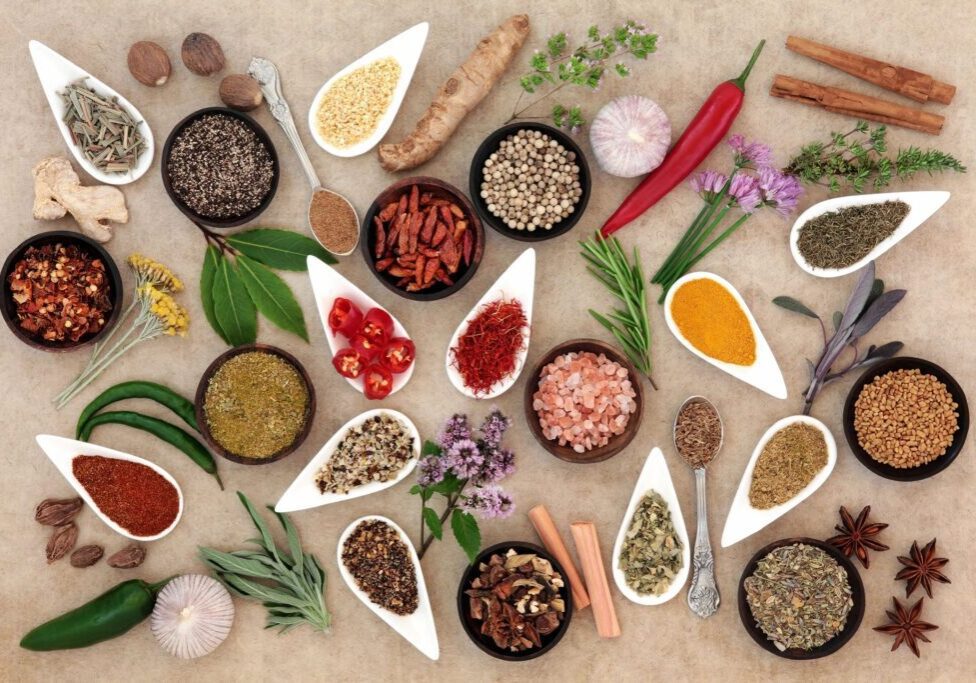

{"left": 769, "top": 74, "right": 945, "bottom": 135}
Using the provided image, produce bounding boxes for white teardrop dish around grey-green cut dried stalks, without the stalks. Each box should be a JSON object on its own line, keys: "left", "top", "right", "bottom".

{"left": 29, "top": 40, "right": 155, "bottom": 185}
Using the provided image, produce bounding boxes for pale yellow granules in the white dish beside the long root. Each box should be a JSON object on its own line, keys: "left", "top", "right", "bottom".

{"left": 316, "top": 57, "right": 400, "bottom": 147}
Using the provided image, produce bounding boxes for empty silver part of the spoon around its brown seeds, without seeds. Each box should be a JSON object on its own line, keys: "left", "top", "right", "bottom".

{"left": 672, "top": 396, "right": 725, "bottom": 618}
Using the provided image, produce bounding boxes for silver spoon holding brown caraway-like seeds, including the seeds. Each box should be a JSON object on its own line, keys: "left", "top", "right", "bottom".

{"left": 674, "top": 396, "right": 724, "bottom": 618}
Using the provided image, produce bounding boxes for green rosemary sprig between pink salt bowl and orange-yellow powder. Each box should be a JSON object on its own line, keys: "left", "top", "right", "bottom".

{"left": 579, "top": 233, "right": 657, "bottom": 389}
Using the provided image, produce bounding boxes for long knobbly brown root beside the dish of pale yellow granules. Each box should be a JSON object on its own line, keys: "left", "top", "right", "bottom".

{"left": 379, "top": 14, "right": 529, "bottom": 172}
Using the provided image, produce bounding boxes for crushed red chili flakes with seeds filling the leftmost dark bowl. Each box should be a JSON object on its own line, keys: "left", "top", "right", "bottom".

{"left": 7, "top": 243, "right": 112, "bottom": 342}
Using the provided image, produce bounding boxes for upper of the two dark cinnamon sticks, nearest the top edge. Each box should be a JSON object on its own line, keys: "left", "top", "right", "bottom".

{"left": 786, "top": 36, "right": 956, "bottom": 104}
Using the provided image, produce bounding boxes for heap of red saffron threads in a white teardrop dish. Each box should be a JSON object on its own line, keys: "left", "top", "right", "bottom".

{"left": 451, "top": 299, "right": 529, "bottom": 394}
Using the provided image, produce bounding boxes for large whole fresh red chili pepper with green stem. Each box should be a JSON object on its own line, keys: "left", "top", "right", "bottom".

{"left": 600, "top": 40, "right": 766, "bottom": 237}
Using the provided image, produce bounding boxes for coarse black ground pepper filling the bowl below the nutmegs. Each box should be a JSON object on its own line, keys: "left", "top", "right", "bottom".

{"left": 166, "top": 114, "right": 274, "bottom": 218}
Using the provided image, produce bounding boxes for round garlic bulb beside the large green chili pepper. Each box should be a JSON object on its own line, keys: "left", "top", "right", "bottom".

{"left": 149, "top": 574, "right": 234, "bottom": 659}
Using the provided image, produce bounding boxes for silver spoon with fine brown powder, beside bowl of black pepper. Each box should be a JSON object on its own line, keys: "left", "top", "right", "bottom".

{"left": 247, "top": 57, "right": 359, "bottom": 256}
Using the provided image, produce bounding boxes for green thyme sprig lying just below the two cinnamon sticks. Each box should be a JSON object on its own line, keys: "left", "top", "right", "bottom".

{"left": 785, "top": 121, "right": 966, "bottom": 192}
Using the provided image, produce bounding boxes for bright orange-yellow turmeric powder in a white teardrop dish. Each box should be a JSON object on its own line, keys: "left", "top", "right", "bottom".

{"left": 671, "top": 278, "right": 756, "bottom": 365}
